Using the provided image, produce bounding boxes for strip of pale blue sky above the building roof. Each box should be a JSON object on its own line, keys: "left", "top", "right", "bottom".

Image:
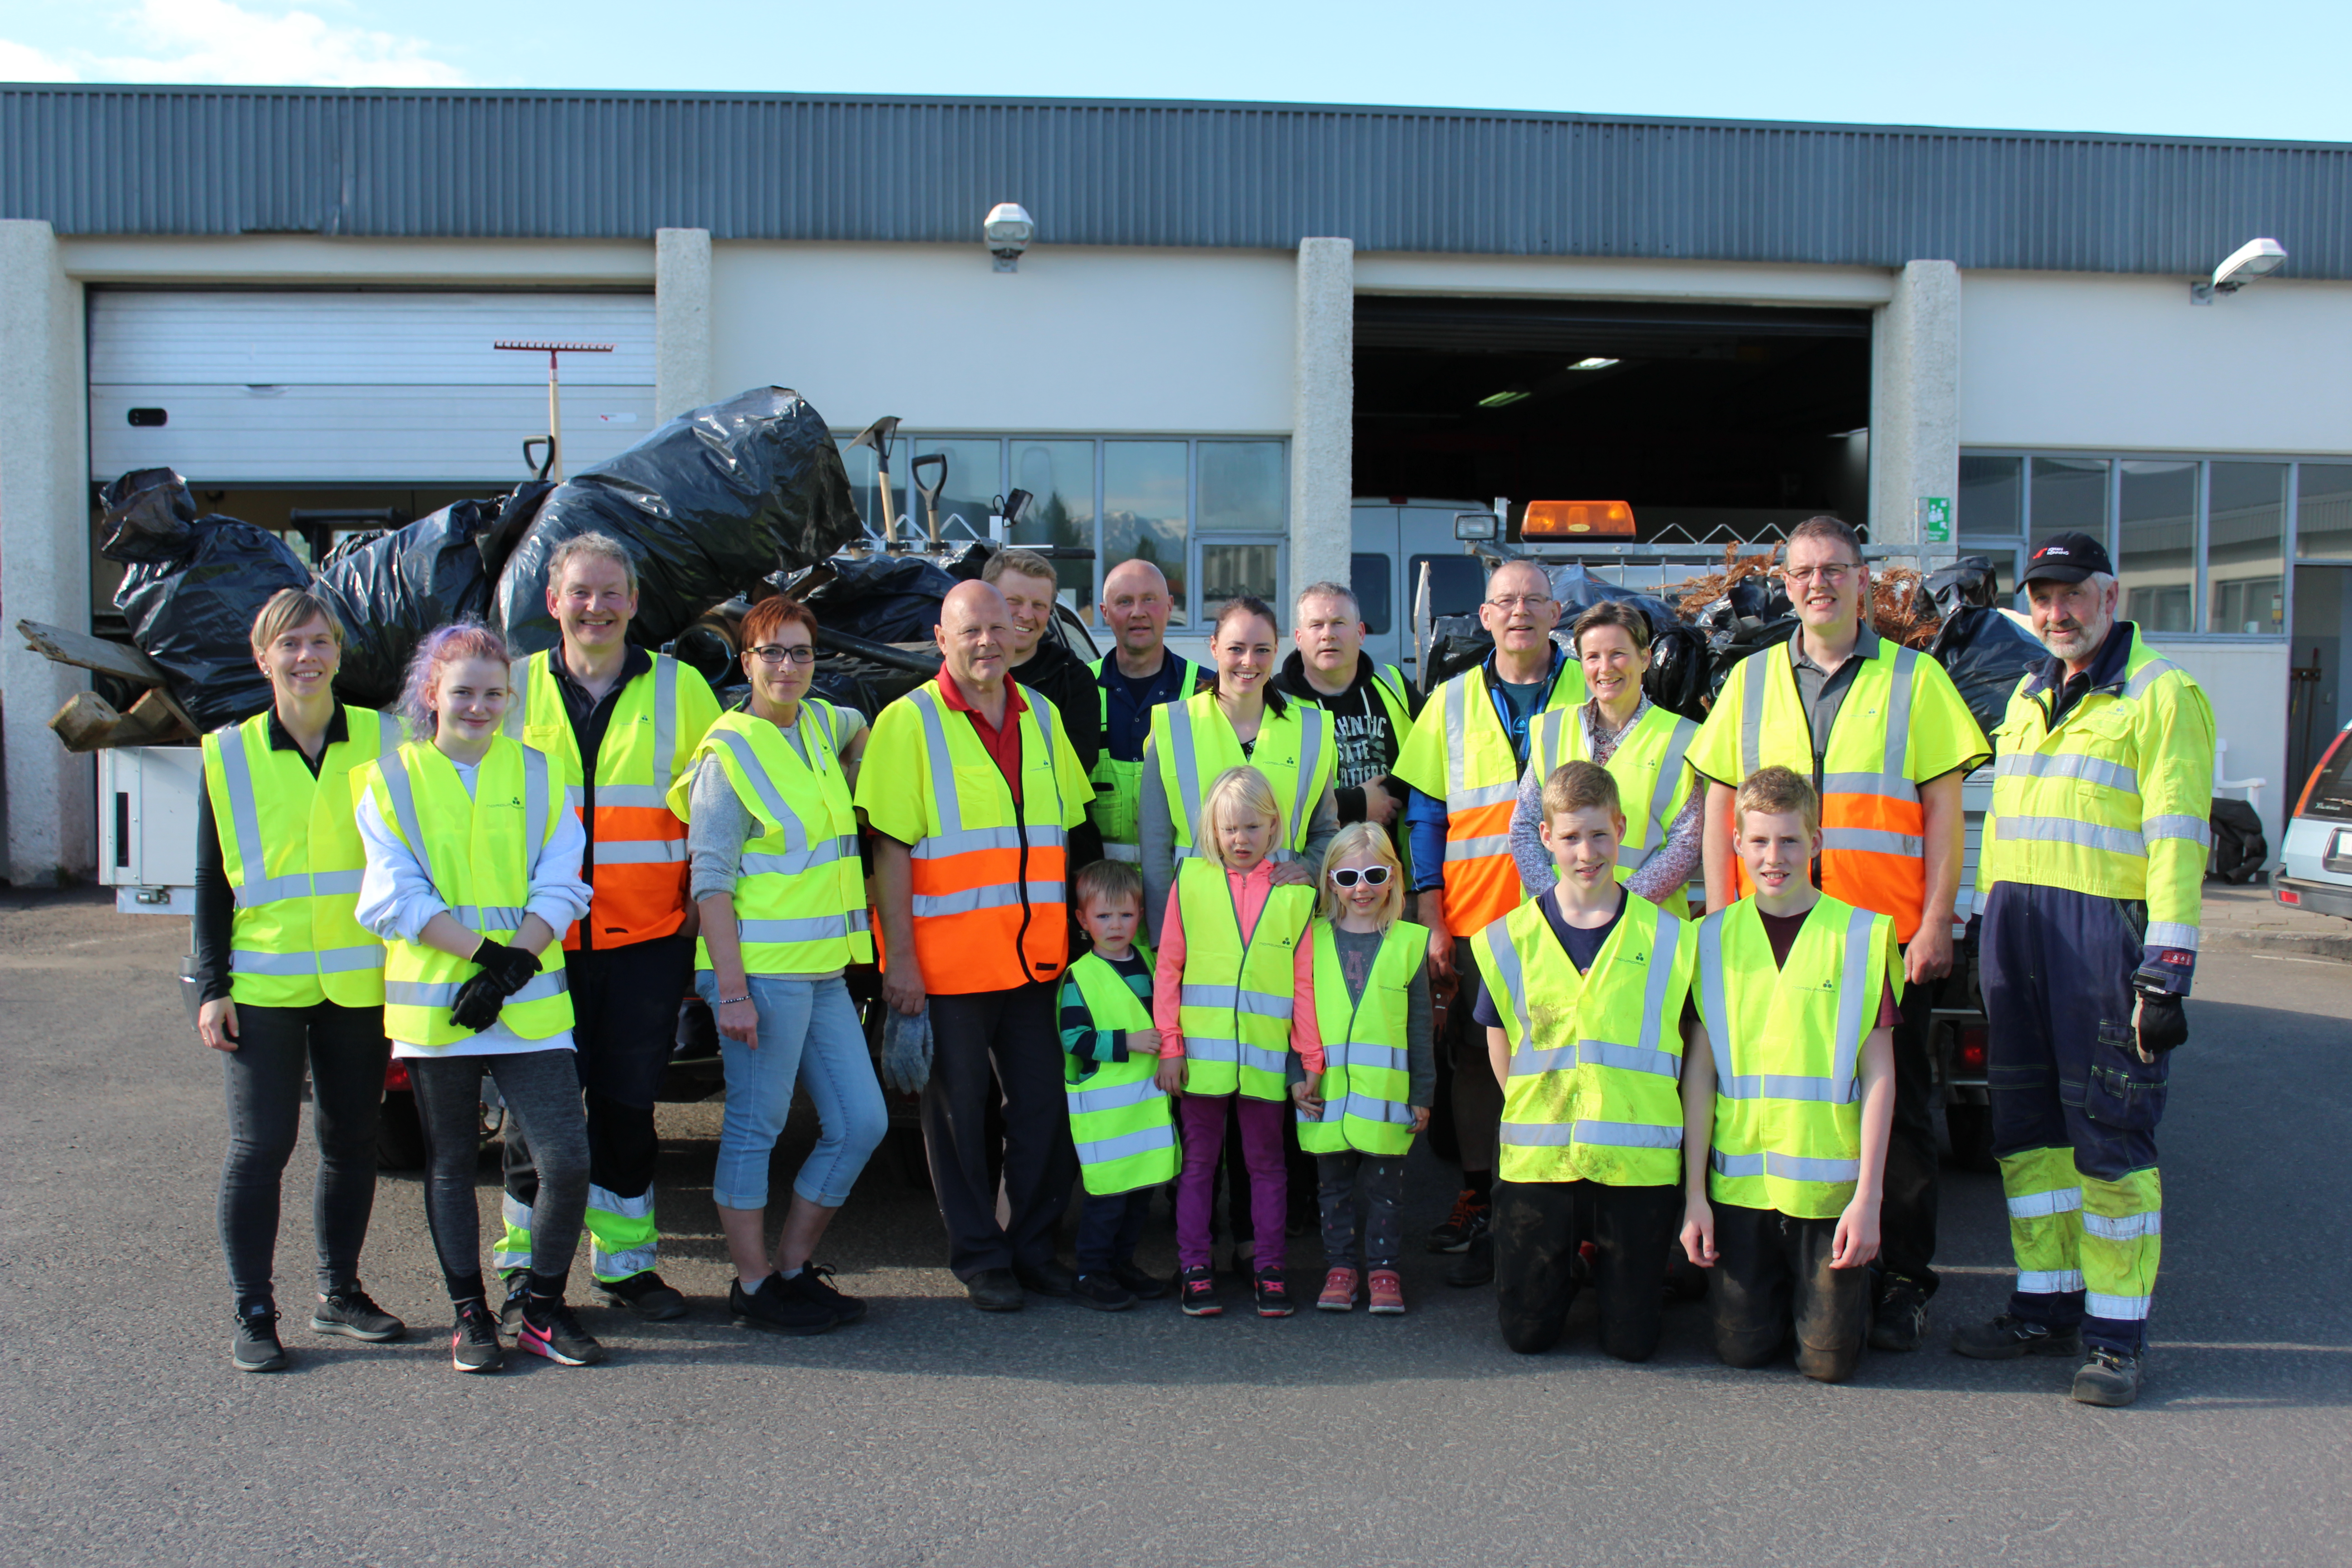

{"left": 0, "top": 0, "right": 2352, "bottom": 141}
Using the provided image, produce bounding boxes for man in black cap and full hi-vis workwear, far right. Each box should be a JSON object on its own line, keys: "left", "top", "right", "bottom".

{"left": 1952, "top": 534, "right": 2213, "bottom": 1406}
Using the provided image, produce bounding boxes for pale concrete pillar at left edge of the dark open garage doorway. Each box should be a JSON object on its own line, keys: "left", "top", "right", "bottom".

{"left": 1282, "top": 240, "right": 1355, "bottom": 616}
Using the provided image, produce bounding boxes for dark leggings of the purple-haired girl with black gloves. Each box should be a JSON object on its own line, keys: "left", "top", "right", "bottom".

{"left": 407, "top": 1051, "right": 588, "bottom": 1303}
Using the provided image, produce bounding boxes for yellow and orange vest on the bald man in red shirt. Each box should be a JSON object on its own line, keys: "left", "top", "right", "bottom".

{"left": 866, "top": 679, "right": 1070, "bottom": 997}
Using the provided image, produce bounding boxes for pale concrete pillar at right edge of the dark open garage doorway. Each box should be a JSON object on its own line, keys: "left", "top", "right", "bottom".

{"left": 1870, "top": 261, "right": 1959, "bottom": 562}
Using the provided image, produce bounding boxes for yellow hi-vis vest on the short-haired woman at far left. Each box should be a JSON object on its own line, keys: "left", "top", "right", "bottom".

{"left": 202, "top": 708, "right": 400, "bottom": 1006}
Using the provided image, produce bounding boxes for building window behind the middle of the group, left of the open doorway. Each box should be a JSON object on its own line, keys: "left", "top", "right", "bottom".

{"left": 838, "top": 432, "right": 1289, "bottom": 627}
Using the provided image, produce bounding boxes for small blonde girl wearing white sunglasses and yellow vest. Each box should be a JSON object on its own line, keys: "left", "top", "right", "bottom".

{"left": 1291, "top": 823, "right": 1437, "bottom": 1317}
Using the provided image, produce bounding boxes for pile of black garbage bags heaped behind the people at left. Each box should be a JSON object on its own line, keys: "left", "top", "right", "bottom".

{"left": 99, "top": 388, "right": 861, "bottom": 729}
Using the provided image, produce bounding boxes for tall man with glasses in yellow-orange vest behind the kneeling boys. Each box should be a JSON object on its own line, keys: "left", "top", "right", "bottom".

{"left": 1689, "top": 517, "right": 1992, "bottom": 1349}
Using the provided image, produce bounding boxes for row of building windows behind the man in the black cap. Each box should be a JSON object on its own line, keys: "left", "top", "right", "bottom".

{"left": 1959, "top": 451, "right": 2352, "bottom": 639}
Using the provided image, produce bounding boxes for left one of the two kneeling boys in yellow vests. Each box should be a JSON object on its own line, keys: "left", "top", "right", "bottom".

{"left": 1475, "top": 762, "right": 1696, "bottom": 1361}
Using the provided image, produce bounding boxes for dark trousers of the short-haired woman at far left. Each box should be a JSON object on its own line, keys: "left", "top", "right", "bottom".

{"left": 219, "top": 1001, "right": 391, "bottom": 1312}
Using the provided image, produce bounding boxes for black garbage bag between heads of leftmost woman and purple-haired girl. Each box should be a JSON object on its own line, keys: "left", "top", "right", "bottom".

{"left": 318, "top": 501, "right": 501, "bottom": 708}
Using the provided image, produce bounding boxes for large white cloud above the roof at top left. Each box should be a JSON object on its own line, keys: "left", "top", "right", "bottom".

{"left": 71, "top": 0, "right": 466, "bottom": 87}
